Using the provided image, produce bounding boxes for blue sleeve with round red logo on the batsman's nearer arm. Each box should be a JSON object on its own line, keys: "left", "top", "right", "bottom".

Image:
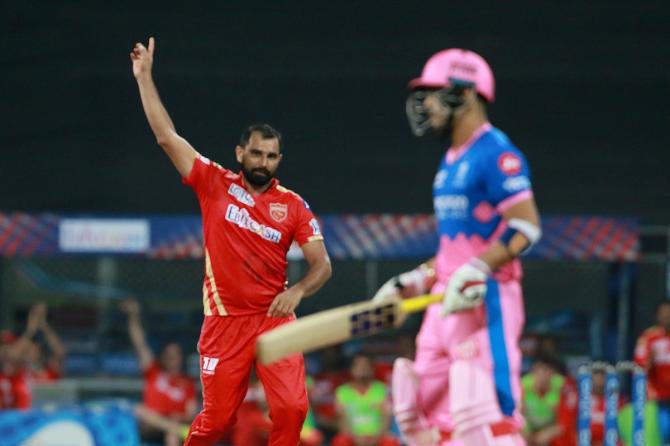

{"left": 483, "top": 146, "right": 532, "bottom": 213}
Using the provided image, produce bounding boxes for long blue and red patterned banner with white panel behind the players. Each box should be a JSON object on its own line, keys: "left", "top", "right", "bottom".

{"left": 0, "top": 212, "right": 640, "bottom": 262}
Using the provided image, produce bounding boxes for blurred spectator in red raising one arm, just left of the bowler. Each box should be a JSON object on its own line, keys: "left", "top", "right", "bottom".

{"left": 121, "top": 299, "right": 196, "bottom": 446}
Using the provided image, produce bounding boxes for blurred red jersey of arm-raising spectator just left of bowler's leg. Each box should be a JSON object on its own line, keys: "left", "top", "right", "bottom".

{"left": 143, "top": 362, "right": 195, "bottom": 417}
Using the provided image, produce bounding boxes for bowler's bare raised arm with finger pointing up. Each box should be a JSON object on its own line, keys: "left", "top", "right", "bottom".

{"left": 130, "top": 37, "right": 198, "bottom": 177}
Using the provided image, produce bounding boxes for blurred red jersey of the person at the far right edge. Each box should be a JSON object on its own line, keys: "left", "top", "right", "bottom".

{"left": 635, "top": 326, "right": 670, "bottom": 401}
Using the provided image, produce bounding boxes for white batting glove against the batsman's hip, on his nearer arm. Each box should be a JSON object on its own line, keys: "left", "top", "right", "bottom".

{"left": 442, "top": 258, "right": 491, "bottom": 317}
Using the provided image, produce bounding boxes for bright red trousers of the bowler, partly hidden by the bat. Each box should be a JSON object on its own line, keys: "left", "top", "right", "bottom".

{"left": 184, "top": 314, "right": 307, "bottom": 446}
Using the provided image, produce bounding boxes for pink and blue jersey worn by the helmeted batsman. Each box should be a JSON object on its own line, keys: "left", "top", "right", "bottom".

{"left": 433, "top": 123, "right": 532, "bottom": 285}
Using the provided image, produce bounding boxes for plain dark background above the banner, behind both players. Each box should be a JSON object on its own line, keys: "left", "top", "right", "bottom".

{"left": 0, "top": 0, "right": 670, "bottom": 223}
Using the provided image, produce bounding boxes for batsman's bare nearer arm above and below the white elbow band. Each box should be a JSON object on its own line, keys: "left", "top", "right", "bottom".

{"left": 479, "top": 197, "right": 540, "bottom": 271}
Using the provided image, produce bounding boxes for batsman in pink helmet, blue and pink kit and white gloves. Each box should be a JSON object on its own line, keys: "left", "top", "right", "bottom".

{"left": 374, "top": 49, "right": 541, "bottom": 446}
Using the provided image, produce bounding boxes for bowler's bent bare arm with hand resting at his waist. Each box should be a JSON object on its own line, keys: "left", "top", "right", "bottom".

{"left": 268, "top": 240, "right": 332, "bottom": 317}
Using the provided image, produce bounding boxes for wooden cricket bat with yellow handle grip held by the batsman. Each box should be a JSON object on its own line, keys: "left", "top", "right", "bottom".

{"left": 256, "top": 294, "right": 443, "bottom": 364}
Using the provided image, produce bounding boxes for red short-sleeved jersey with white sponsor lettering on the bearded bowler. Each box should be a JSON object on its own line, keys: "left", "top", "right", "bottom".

{"left": 183, "top": 156, "right": 323, "bottom": 316}
